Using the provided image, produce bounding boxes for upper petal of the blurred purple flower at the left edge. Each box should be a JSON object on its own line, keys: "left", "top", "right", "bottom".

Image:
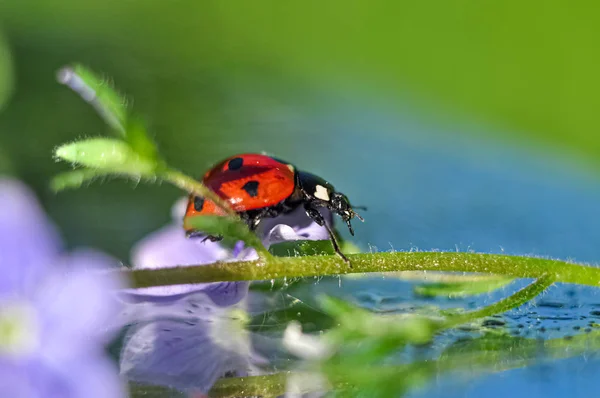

{"left": 0, "top": 179, "right": 61, "bottom": 298}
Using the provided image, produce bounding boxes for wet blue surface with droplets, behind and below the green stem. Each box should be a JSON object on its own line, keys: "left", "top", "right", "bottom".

{"left": 274, "top": 104, "right": 600, "bottom": 398}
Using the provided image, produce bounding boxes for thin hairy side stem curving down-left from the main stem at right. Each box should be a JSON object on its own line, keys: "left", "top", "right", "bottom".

{"left": 440, "top": 275, "right": 555, "bottom": 329}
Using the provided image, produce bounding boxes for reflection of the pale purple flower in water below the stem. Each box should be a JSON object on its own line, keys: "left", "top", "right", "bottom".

{"left": 121, "top": 294, "right": 251, "bottom": 393}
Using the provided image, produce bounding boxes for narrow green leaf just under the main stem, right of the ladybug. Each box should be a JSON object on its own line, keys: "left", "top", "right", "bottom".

{"left": 414, "top": 276, "right": 513, "bottom": 298}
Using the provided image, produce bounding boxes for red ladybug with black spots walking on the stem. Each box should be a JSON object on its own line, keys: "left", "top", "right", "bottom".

{"left": 184, "top": 153, "right": 363, "bottom": 262}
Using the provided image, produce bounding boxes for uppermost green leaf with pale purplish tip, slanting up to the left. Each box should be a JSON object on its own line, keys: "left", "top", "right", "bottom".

{"left": 57, "top": 64, "right": 127, "bottom": 136}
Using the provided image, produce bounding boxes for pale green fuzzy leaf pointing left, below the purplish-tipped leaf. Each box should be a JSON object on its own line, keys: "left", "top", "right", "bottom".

{"left": 54, "top": 138, "right": 157, "bottom": 175}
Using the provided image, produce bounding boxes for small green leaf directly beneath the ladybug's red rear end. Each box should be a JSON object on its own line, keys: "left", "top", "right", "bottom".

{"left": 185, "top": 215, "right": 270, "bottom": 256}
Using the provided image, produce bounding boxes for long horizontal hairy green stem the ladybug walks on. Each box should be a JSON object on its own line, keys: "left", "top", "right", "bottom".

{"left": 119, "top": 252, "right": 600, "bottom": 287}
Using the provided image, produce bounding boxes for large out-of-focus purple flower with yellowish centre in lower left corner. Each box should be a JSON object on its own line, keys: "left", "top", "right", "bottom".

{"left": 0, "top": 179, "right": 125, "bottom": 398}
